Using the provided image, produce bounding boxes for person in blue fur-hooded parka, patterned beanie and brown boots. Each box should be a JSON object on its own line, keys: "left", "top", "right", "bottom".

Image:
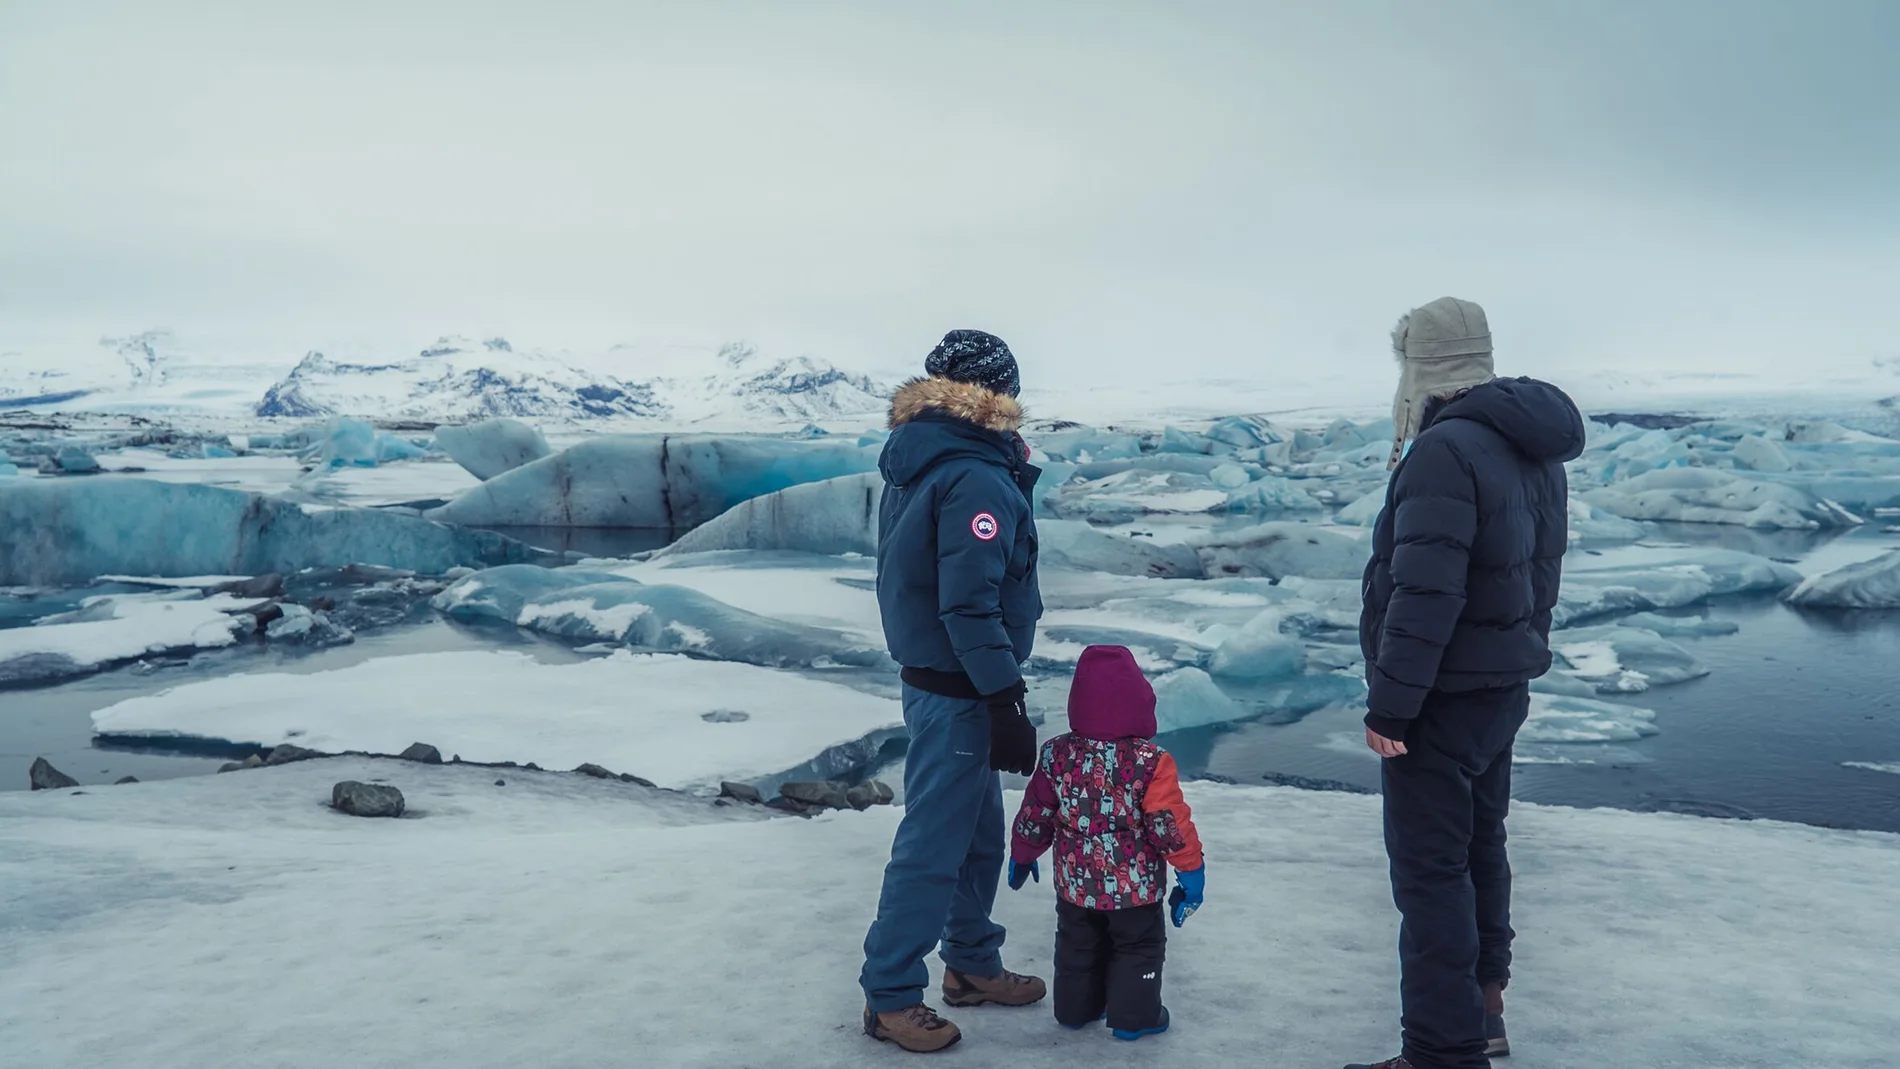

{"left": 859, "top": 330, "right": 1045, "bottom": 1052}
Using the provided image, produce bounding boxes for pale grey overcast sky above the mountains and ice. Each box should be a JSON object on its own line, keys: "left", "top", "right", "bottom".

{"left": 0, "top": 0, "right": 1900, "bottom": 384}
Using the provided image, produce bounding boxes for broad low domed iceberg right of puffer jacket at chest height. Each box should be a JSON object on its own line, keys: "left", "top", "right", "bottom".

{"left": 1581, "top": 467, "right": 1862, "bottom": 530}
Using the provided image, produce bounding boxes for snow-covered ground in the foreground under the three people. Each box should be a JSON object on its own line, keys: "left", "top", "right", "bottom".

{"left": 0, "top": 758, "right": 1900, "bottom": 1069}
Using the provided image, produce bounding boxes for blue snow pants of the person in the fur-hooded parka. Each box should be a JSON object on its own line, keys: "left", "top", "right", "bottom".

{"left": 859, "top": 684, "right": 1009, "bottom": 1014}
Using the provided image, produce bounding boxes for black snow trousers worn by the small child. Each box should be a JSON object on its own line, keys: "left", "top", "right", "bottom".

{"left": 1055, "top": 898, "right": 1169, "bottom": 1031}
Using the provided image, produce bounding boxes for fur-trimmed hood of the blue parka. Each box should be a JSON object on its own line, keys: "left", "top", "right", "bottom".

{"left": 878, "top": 378, "right": 1024, "bottom": 486}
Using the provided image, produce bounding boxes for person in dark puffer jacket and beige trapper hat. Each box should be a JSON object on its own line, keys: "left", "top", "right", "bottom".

{"left": 1359, "top": 298, "right": 1585, "bottom": 1069}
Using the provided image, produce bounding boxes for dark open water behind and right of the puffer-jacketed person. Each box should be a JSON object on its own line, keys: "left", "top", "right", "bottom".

{"left": 1165, "top": 528, "right": 1900, "bottom": 832}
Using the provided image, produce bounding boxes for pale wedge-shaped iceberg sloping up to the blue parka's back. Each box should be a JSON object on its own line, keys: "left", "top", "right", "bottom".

{"left": 656, "top": 471, "right": 881, "bottom": 558}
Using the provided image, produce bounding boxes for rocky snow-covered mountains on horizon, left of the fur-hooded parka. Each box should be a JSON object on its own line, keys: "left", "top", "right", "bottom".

{"left": 255, "top": 338, "right": 889, "bottom": 423}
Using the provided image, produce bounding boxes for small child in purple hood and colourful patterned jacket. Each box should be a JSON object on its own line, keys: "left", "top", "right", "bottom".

{"left": 1009, "top": 646, "right": 1205, "bottom": 1041}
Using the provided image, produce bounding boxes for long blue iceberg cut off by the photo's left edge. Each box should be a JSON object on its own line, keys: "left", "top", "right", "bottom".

{"left": 0, "top": 478, "right": 547, "bottom": 587}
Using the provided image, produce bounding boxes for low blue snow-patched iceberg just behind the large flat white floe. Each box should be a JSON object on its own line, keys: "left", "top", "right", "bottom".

{"left": 431, "top": 566, "right": 897, "bottom": 670}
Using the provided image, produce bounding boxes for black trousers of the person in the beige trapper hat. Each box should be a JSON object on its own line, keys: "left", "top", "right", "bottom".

{"left": 1381, "top": 685, "right": 1530, "bottom": 1069}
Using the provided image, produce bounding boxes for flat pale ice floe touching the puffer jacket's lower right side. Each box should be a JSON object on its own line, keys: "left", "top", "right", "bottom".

{"left": 1552, "top": 549, "right": 1801, "bottom": 627}
